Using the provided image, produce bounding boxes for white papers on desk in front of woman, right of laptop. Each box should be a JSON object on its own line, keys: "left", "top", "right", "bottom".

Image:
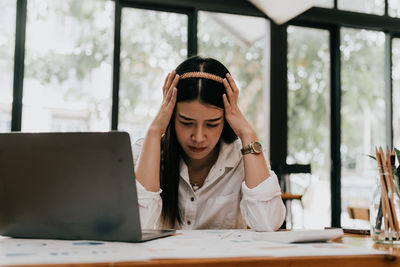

{"left": 142, "top": 230, "right": 388, "bottom": 259}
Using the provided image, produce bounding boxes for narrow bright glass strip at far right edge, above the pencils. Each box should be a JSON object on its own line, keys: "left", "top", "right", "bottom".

{"left": 392, "top": 39, "right": 400, "bottom": 149}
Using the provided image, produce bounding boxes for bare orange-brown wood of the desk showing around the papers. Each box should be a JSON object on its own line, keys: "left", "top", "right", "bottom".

{"left": 8, "top": 237, "right": 400, "bottom": 267}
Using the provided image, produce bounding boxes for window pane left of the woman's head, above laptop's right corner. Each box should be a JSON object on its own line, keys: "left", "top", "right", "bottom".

{"left": 118, "top": 8, "right": 188, "bottom": 141}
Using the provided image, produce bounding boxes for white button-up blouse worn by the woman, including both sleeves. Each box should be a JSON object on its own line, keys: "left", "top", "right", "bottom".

{"left": 133, "top": 140, "right": 286, "bottom": 231}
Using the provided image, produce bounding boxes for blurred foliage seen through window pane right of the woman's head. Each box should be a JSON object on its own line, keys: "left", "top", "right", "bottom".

{"left": 198, "top": 12, "right": 266, "bottom": 144}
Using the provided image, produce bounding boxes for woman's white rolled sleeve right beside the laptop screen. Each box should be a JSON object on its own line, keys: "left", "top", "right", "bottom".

{"left": 132, "top": 139, "right": 162, "bottom": 229}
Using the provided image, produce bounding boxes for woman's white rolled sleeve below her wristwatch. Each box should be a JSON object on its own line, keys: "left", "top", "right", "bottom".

{"left": 240, "top": 170, "right": 286, "bottom": 231}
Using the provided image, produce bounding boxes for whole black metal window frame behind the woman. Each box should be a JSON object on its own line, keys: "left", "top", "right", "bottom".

{"left": 11, "top": 0, "right": 400, "bottom": 227}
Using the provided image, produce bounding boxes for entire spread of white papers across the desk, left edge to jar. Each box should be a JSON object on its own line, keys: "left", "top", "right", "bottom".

{"left": 0, "top": 230, "right": 388, "bottom": 266}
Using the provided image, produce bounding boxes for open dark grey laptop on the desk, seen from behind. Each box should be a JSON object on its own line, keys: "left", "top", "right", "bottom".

{"left": 0, "top": 131, "right": 175, "bottom": 242}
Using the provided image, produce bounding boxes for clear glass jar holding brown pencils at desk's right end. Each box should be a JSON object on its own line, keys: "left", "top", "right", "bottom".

{"left": 370, "top": 170, "right": 400, "bottom": 244}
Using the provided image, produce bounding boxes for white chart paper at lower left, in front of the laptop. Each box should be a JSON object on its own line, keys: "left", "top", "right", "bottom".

{"left": 0, "top": 238, "right": 149, "bottom": 266}
